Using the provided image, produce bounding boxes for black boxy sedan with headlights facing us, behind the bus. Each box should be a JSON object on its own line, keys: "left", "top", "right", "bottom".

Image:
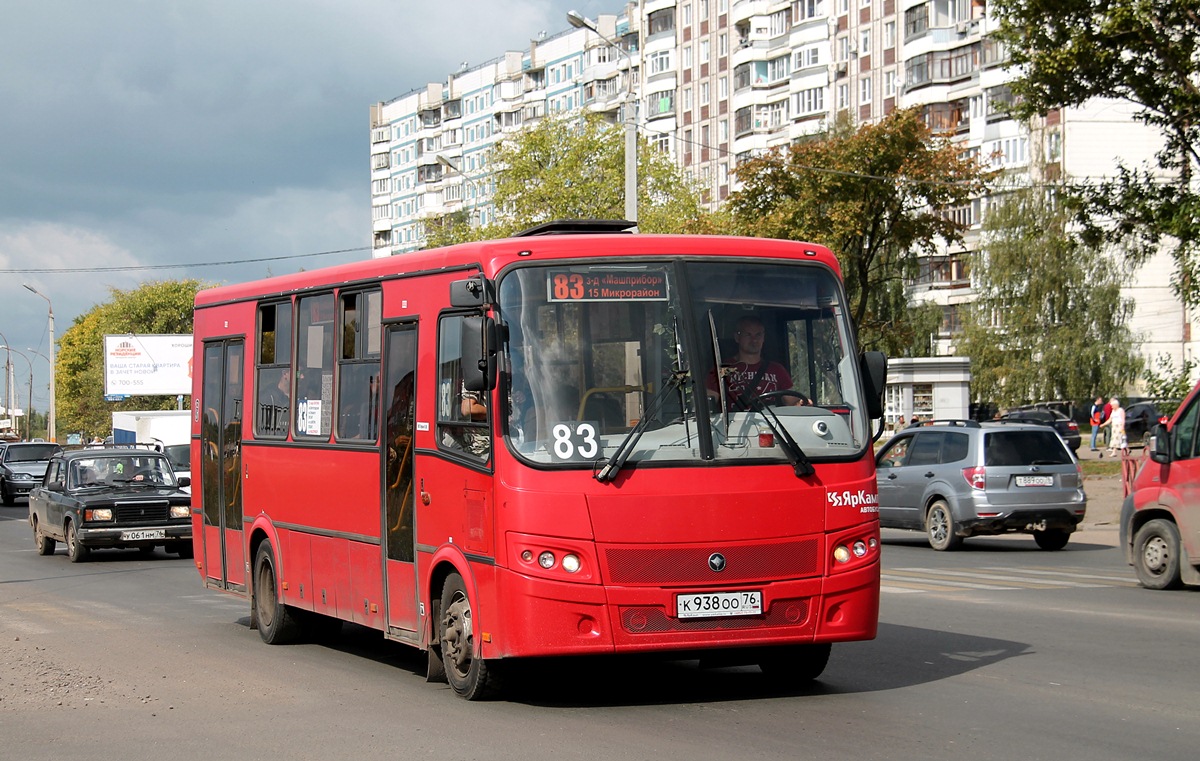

{"left": 29, "top": 449, "right": 192, "bottom": 563}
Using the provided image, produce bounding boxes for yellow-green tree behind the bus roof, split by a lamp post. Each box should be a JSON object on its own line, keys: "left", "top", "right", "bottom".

{"left": 425, "top": 114, "right": 704, "bottom": 247}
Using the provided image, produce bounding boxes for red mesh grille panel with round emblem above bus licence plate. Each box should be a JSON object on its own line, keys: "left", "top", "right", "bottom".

{"left": 605, "top": 539, "right": 821, "bottom": 586}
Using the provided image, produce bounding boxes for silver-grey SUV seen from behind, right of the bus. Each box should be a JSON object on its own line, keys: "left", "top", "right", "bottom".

{"left": 875, "top": 420, "right": 1087, "bottom": 550}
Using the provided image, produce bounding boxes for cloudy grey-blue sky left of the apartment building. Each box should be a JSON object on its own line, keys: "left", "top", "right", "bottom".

{"left": 0, "top": 0, "right": 604, "bottom": 420}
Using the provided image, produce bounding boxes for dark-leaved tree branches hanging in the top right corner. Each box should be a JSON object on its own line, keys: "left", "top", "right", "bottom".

{"left": 994, "top": 0, "right": 1200, "bottom": 306}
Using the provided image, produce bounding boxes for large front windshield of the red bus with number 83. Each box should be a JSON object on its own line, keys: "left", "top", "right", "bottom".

{"left": 498, "top": 259, "right": 870, "bottom": 468}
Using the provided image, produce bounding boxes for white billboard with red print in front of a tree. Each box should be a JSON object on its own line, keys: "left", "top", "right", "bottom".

{"left": 104, "top": 332, "right": 192, "bottom": 396}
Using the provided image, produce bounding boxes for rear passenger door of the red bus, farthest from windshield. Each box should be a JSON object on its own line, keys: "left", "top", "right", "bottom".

{"left": 200, "top": 338, "right": 246, "bottom": 591}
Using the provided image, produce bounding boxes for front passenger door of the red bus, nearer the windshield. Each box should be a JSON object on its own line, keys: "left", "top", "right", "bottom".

{"left": 382, "top": 323, "right": 419, "bottom": 639}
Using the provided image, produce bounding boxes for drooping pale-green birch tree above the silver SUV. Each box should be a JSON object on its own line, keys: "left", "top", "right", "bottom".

{"left": 956, "top": 181, "right": 1141, "bottom": 406}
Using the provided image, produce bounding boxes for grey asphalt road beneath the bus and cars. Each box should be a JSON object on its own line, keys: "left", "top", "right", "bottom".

{"left": 0, "top": 503, "right": 1200, "bottom": 761}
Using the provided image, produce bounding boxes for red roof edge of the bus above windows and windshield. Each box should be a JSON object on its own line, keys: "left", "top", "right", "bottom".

{"left": 196, "top": 233, "right": 841, "bottom": 307}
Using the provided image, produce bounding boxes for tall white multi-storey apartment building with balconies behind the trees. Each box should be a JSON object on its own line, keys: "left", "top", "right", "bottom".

{"left": 371, "top": 0, "right": 1194, "bottom": 372}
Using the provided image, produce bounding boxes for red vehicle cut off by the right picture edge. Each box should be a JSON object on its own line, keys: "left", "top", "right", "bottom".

{"left": 1120, "top": 384, "right": 1200, "bottom": 589}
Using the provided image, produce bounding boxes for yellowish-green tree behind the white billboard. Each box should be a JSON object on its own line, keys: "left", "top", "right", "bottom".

{"left": 55, "top": 280, "right": 204, "bottom": 438}
